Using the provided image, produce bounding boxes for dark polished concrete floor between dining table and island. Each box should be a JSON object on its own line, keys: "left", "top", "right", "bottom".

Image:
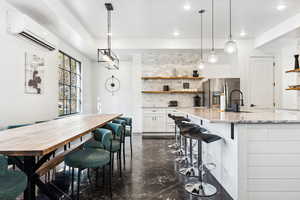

{"left": 38, "top": 135, "right": 231, "bottom": 200}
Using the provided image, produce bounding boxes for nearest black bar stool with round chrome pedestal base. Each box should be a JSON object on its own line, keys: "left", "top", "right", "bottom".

{"left": 184, "top": 127, "right": 222, "bottom": 197}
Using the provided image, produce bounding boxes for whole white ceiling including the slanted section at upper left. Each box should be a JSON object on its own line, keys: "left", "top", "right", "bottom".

{"left": 6, "top": 0, "right": 300, "bottom": 59}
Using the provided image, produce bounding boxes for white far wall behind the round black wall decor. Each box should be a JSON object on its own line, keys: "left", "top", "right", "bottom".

{"left": 93, "top": 55, "right": 142, "bottom": 132}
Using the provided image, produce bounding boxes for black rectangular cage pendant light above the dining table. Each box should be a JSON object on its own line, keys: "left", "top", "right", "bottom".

{"left": 98, "top": 3, "right": 119, "bottom": 69}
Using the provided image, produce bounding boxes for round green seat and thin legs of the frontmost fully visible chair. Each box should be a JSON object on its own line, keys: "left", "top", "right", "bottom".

{"left": 65, "top": 145, "right": 112, "bottom": 200}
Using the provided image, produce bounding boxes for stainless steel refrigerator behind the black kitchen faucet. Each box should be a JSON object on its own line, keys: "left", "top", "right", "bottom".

{"left": 203, "top": 78, "right": 240, "bottom": 108}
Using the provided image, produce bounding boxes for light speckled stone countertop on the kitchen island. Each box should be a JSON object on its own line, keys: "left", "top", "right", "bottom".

{"left": 177, "top": 108, "right": 300, "bottom": 124}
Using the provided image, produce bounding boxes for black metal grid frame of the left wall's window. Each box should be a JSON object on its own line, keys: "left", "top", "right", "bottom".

{"left": 58, "top": 50, "right": 82, "bottom": 117}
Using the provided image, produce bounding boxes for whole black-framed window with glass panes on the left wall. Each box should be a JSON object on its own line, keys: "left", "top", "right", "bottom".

{"left": 58, "top": 51, "right": 82, "bottom": 116}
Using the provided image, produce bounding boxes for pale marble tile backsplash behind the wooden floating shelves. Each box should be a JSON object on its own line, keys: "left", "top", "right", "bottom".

{"left": 142, "top": 52, "right": 202, "bottom": 107}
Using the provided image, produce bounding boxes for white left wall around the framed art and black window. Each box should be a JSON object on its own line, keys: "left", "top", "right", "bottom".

{"left": 0, "top": 0, "right": 92, "bottom": 127}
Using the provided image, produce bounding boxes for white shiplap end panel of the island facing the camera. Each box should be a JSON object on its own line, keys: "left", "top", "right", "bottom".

{"left": 238, "top": 124, "right": 300, "bottom": 200}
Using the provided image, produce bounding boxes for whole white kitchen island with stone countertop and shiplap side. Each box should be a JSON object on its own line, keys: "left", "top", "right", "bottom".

{"left": 178, "top": 108, "right": 300, "bottom": 200}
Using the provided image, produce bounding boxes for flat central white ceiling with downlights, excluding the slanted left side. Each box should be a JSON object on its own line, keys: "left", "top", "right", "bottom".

{"left": 61, "top": 0, "right": 300, "bottom": 38}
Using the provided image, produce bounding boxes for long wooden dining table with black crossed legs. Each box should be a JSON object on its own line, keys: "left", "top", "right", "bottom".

{"left": 0, "top": 114, "right": 122, "bottom": 200}
